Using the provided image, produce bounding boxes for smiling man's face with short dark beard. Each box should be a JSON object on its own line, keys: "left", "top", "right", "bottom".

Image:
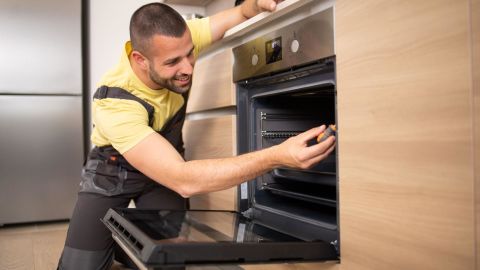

{"left": 144, "top": 29, "right": 195, "bottom": 94}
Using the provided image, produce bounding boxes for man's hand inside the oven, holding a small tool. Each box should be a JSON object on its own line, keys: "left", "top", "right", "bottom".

{"left": 275, "top": 126, "right": 335, "bottom": 169}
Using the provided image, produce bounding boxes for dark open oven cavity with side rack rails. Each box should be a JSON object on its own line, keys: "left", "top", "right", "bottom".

{"left": 255, "top": 79, "right": 337, "bottom": 242}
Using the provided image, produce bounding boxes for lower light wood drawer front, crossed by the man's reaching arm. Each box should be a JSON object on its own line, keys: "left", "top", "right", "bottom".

{"left": 184, "top": 115, "right": 237, "bottom": 210}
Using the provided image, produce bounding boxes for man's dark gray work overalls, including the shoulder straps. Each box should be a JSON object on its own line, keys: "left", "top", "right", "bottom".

{"left": 58, "top": 86, "right": 188, "bottom": 270}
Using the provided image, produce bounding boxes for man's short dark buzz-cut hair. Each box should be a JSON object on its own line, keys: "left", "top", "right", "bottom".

{"left": 130, "top": 3, "right": 187, "bottom": 55}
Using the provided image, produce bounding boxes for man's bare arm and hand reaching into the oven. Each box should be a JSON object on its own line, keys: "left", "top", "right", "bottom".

{"left": 123, "top": 126, "right": 335, "bottom": 197}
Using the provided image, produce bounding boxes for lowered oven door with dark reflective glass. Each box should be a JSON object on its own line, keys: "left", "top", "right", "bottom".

{"left": 102, "top": 208, "right": 338, "bottom": 268}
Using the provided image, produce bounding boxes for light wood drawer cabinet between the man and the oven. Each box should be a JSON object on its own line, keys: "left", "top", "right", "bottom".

{"left": 184, "top": 49, "right": 237, "bottom": 213}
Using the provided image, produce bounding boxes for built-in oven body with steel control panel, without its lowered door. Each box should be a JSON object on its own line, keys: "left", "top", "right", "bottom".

{"left": 233, "top": 4, "right": 339, "bottom": 249}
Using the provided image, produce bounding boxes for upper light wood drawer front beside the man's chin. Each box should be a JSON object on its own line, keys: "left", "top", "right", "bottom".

{"left": 187, "top": 49, "right": 236, "bottom": 113}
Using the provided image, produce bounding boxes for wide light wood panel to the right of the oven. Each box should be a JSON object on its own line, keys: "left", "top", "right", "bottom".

{"left": 335, "top": 0, "right": 475, "bottom": 270}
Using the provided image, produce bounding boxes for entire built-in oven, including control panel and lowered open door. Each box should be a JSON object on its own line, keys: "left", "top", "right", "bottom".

{"left": 103, "top": 7, "right": 340, "bottom": 269}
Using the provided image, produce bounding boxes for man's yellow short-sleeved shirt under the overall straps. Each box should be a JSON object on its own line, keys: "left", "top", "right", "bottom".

{"left": 91, "top": 18, "right": 212, "bottom": 154}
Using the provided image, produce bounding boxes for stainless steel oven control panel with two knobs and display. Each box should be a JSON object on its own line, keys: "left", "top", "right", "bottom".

{"left": 233, "top": 7, "right": 335, "bottom": 82}
